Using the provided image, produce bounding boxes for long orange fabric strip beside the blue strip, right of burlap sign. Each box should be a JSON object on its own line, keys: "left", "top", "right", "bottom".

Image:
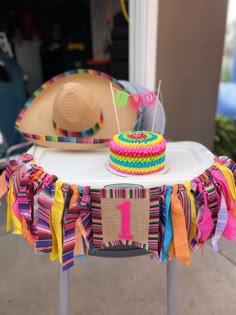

{"left": 170, "top": 185, "right": 191, "bottom": 266}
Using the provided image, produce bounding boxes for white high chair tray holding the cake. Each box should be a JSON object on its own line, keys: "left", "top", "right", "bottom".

{"left": 28, "top": 141, "right": 214, "bottom": 188}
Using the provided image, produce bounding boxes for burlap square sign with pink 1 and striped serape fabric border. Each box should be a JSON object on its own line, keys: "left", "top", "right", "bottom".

{"left": 91, "top": 188, "right": 159, "bottom": 249}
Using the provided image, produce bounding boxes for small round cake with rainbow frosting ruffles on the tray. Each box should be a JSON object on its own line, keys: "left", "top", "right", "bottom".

{"left": 109, "top": 131, "right": 166, "bottom": 175}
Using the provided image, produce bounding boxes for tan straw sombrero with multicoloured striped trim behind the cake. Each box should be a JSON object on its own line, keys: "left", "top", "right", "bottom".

{"left": 16, "top": 69, "right": 139, "bottom": 150}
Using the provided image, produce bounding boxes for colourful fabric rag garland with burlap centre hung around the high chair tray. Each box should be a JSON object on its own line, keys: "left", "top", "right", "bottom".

{"left": 0, "top": 154, "right": 236, "bottom": 270}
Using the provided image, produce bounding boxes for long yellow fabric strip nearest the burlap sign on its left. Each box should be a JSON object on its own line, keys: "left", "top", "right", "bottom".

{"left": 50, "top": 180, "right": 64, "bottom": 263}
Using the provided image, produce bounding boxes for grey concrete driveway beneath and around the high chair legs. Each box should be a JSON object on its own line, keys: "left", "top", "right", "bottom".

{"left": 0, "top": 199, "right": 236, "bottom": 315}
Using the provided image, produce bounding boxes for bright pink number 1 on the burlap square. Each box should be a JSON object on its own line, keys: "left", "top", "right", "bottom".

{"left": 117, "top": 201, "right": 133, "bottom": 240}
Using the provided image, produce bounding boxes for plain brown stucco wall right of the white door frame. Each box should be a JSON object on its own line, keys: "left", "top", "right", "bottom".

{"left": 157, "top": 0, "right": 227, "bottom": 149}
